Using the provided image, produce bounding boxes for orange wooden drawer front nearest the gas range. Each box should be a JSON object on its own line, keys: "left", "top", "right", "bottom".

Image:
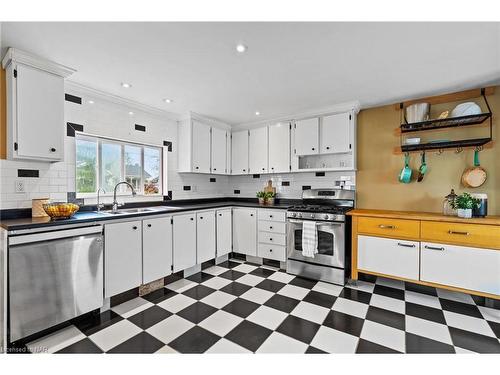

{"left": 358, "top": 217, "right": 420, "bottom": 238}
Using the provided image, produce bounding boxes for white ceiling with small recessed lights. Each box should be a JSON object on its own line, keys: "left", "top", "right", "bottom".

{"left": 2, "top": 22, "right": 500, "bottom": 124}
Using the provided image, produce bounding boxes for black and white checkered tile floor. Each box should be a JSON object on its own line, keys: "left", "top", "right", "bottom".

{"left": 27, "top": 260, "right": 500, "bottom": 353}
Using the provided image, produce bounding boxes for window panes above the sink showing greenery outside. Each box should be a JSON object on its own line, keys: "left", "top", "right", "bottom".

{"left": 76, "top": 134, "right": 163, "bottom": 195}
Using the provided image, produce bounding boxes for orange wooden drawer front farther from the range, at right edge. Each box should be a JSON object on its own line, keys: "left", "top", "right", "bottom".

{"left": 422, "top": 221, "right": 500, "bottom": 249}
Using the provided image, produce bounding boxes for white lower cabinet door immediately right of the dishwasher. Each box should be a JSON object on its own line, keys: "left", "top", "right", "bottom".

{"left": 104, "top": 220, "right": 142, "bottom": 298}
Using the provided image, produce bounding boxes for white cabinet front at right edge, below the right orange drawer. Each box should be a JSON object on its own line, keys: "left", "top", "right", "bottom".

{"left": 420, "top": 242, "right": 500, "bottom": 295}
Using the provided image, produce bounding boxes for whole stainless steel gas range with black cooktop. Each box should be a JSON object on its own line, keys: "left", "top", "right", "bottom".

{"left": 286, "top": 189, "right": 355, "bottom": 285}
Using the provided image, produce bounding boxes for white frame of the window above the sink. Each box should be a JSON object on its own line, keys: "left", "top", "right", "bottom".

{"left": 75, "top": 132, "right": 167, "bottom": 198}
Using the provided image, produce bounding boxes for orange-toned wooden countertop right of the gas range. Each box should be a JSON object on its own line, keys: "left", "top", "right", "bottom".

{"left": 347, "top": 209, "right": 500, "bottom": 225}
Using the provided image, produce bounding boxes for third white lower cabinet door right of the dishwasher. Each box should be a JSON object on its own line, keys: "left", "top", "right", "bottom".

{"left": 173, "top": 213, "right": 196, "bottom": 272}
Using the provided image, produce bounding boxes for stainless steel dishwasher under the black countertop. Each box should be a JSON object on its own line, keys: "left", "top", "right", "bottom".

{"left": 8, "top": 225, "right": 103, "bottom": 342}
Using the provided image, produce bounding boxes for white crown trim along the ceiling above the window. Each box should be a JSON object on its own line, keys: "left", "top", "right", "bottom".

{"left": 64, "top": 80, "right": 181, "bottom": 121}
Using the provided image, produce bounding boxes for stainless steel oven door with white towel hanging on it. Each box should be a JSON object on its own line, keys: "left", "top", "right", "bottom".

{"left": 287, "top": 219, "right": 345, "bottom": 268}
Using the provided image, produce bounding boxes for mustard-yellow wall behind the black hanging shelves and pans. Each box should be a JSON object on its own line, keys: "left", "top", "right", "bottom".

{"left": 356, "top": 87, "right": 500, "bottom": 215}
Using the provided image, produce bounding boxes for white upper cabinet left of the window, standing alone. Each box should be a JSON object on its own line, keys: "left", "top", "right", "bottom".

{"left": 3, "top": 48, "right": 74, "bottom": 161}
